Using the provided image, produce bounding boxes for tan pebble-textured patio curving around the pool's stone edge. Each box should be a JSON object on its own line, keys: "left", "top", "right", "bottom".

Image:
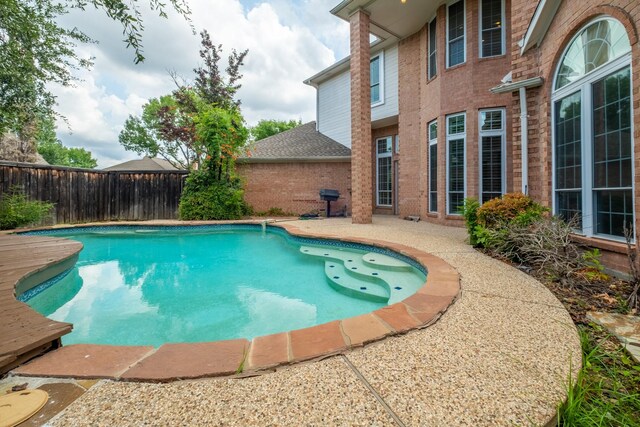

{"left": 42, "top": 216, "right": 580, "bottom": 426}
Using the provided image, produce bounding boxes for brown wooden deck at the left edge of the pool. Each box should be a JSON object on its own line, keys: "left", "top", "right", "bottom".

{"left": 0, "top": 235, "right": 82, "bottom": 374}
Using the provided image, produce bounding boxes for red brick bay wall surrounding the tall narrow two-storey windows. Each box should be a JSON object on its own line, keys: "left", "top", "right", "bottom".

{"left": 398, "top": 0, "right": 513, "bottom": 225}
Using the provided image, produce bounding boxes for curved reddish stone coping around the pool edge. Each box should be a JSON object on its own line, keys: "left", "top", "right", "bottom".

{"left": 7, "top": 221, "right": 460, "bottom": 382}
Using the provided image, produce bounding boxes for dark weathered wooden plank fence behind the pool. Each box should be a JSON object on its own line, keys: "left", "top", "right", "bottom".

{"left": 0, "top": 162, "right": 187, "bottom": 224}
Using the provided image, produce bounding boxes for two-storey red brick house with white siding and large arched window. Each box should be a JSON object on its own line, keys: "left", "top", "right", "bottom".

{"left": 305, "top": 0, "right": 640, "bottom": 269}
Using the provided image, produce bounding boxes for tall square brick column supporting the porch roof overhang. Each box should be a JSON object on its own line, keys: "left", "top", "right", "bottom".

{"left": 350, "top": 10, "right": 373, "bottom": 224}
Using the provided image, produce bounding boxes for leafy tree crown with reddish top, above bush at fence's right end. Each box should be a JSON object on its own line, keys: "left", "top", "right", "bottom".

{"left": 119, "top": 31, "right": 248, "bottom": 171}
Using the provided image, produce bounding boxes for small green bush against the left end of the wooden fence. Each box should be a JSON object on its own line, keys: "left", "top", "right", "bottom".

{"left": 0, "top": 187, "right": 53, "bottom": 230}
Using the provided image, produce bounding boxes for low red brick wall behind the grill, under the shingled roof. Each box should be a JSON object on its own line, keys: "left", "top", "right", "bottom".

{"left": 237, "top": 162, "right": 351, "bottom": 215}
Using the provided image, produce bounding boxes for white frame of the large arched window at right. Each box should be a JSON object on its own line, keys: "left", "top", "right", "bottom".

{"left": 550, "top": 16, "right": 638, "bottom": 243}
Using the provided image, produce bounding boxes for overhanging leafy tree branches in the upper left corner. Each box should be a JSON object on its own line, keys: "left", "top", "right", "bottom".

{"left": 0, "top": 0, "right": 190, "bottom": 140}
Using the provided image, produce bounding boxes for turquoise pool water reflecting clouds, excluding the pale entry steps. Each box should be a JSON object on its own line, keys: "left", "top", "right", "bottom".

{"left": 23, "top": 227, "right": 424, "bottom": 346}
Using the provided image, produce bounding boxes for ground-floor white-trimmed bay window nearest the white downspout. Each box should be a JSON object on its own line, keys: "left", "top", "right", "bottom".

{"left": 478, "top": 108, "right": 506, "bottom": 203}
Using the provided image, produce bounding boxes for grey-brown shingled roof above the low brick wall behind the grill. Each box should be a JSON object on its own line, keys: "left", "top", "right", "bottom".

{"left": 241, "top": 122, "right": 351, "bottom": 162}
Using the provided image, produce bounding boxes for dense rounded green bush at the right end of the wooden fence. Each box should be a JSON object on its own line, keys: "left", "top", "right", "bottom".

{"left": 179, "top": 171, "right": 250, "bottom": 220}
